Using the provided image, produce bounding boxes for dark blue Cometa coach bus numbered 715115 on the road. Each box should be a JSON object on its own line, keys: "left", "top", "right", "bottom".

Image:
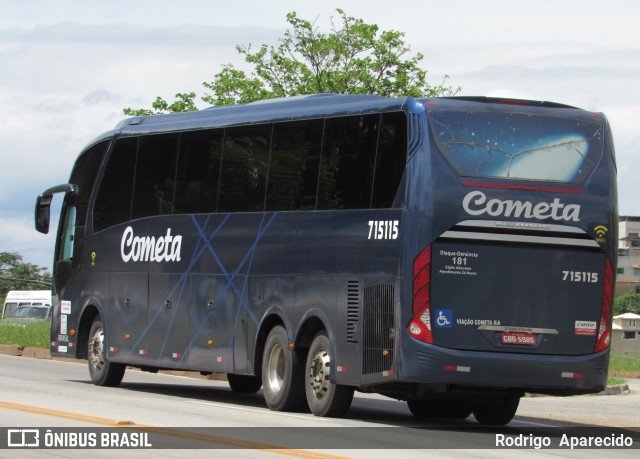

{"left": 35, "top": 94, "right": 617, "bottom": 425}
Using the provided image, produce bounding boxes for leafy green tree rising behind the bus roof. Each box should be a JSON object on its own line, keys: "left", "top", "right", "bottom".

{"left": 124, "top": 9, "right": 460, "bottom": 116}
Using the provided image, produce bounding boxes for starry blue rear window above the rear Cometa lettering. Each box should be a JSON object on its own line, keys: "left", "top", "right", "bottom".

{"left": 429, "top": 110, "right": 602, "bottom": 183}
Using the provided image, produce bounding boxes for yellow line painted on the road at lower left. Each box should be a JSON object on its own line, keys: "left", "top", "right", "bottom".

{"left": 0, "top": 400, "right": 348, "bottom": 459}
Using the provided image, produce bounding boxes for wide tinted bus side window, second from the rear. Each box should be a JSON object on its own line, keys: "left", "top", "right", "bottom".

{"left": 317, "top": 114, "right": 380, "bottom": 209}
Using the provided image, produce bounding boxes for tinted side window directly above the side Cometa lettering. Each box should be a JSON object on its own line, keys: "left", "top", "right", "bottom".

{"left": 131, "top": 134, "right": 180, "bottom": 220}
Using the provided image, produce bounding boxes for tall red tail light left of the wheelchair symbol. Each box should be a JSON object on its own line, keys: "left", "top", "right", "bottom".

{"left": 407, "top": 246, "right": 433, "bottom": 344}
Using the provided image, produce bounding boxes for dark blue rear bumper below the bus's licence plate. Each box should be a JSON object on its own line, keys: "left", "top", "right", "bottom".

{"left": 398, "top": 338, "right": 609, "bottom": 395}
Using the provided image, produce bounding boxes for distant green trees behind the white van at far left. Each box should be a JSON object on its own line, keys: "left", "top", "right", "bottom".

{"left": 0, "top": 252, "right": 51, "bottom": 303}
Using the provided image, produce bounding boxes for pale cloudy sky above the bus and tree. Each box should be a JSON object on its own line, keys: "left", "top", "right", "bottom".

{"left": 0, "top": 0, "right": 640, "bottom": 269}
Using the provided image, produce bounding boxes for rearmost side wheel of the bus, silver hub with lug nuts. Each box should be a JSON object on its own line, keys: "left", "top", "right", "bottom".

{"left": 304, "top": 332, "right": 354, "bottom": 417}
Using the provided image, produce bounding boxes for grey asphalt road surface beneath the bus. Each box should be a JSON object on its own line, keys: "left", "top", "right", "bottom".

{"left": 0, "top": 355, "right": 640, "bottom": 459}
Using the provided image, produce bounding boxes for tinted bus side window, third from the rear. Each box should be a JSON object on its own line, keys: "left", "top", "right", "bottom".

{"left": 266, "top": 119, "right": 324, "bottom": 211}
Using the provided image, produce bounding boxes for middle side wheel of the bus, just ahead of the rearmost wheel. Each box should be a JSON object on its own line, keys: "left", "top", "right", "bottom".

{"left": 262, "top": 325, "right": 304, "bottom": 411}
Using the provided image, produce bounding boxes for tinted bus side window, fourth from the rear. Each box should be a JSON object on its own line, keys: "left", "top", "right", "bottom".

{"left": 218, "top": 124, "right": 272, "bottom": 212}
